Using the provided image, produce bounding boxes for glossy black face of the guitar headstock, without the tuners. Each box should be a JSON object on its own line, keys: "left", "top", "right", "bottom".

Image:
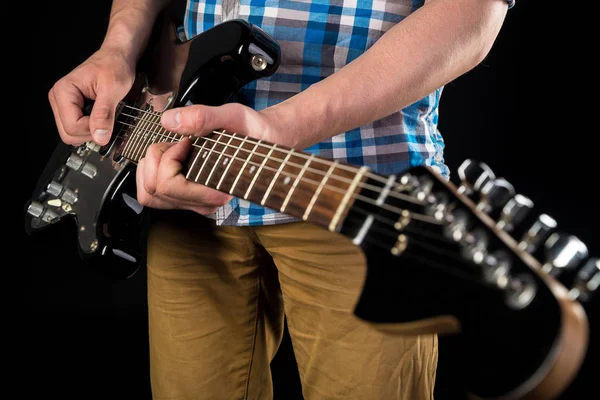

{"left": 342, "top": 167, "right": 561, "bottom": 398}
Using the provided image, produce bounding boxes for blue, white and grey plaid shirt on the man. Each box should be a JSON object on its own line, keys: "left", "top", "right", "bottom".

{"left": 183, "top": 0, "right": 513, "bottom": 225}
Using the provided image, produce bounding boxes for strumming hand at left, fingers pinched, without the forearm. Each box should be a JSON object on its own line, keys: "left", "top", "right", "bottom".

{"left": 48, "top": 48, "right": 135, "bottom": 145}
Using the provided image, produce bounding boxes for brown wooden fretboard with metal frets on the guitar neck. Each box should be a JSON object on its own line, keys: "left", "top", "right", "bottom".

{"left": 112, "top": 104, "right": 367, "bottom": 231}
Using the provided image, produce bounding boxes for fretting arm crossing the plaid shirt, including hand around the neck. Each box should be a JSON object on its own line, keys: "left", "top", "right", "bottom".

{"left": 138, "top": 0, "right": 508, "bottom": 213}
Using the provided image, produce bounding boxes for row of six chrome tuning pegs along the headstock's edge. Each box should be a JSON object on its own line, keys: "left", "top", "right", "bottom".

{"left": 451, "top": 160, "right": 600, "bottom": 302}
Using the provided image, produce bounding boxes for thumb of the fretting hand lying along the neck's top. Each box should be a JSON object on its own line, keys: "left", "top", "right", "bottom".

{"left": 161, "top": 103, "right": 265, "bottom": 135}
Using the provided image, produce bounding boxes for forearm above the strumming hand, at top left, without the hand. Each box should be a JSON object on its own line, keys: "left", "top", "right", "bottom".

{"left": 102, "top": 0, "right": 172, "bottom": 65}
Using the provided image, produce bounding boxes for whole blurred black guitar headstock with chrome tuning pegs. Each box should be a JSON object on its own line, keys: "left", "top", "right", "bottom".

{"left": 343, "top": 160, "right": 600, "bottom": 398}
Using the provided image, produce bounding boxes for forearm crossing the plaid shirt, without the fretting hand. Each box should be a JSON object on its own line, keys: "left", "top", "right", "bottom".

{"left": 264, "top": 0, "right": 507, "bottom": 148}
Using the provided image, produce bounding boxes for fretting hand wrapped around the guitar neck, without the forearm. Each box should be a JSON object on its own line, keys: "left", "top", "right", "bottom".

{"left": 137, "top": 104, "right": 289, "bottom": 215}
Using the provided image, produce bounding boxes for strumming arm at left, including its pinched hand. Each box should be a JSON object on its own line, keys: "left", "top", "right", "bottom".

{"left": 48, "top": 0, "right": 171, "bottom": 145}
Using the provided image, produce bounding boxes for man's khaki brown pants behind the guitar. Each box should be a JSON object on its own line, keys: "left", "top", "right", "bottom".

{"left": 148, "top": 212, "right": 438, "bottom": 400}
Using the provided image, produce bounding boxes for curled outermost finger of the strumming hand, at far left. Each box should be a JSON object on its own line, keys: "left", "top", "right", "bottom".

{"left": 52, "top": 82, "right": 91, "bottom": 137}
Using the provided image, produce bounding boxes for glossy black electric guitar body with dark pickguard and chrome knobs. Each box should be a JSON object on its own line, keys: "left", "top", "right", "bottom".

{"left": 25, "top": 14, "right": 280, "bottom": 279}
